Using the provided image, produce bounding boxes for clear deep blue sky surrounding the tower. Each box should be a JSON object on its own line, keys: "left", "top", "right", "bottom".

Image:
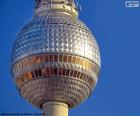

{"left": 0, "top": 0, "right": 140, "bottom": 116}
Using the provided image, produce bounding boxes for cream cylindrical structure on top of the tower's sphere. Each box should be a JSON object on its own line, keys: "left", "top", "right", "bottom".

{"left": 35, "top": 0, "right": 78, "bottom": 17}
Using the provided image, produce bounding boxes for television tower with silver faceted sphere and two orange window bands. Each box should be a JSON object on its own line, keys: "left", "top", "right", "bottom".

{"left": 11, "top": 0, "right": 100, "bottom": 116}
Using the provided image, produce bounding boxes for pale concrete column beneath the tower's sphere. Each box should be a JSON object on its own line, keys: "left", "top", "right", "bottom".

{"left": 43, "top": 101, "right": 69, "bottom": 116}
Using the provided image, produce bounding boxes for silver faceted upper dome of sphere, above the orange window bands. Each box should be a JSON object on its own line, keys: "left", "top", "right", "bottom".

{"left": 12, "top": 13, "right": 100, "bottom": 67}
